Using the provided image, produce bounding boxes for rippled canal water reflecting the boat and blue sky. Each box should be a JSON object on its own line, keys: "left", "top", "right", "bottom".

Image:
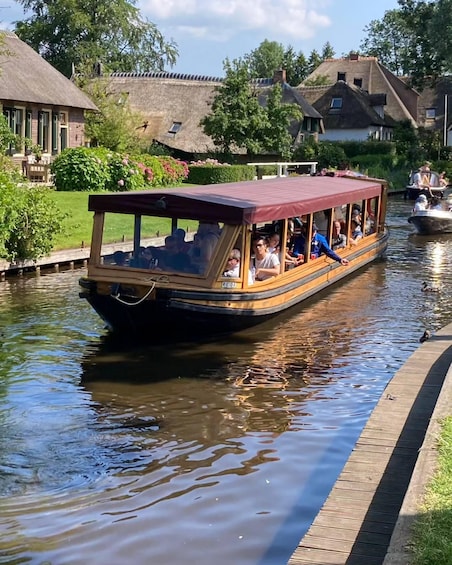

{"left": 0, "top": 197, "right": 452, "bottom": 565}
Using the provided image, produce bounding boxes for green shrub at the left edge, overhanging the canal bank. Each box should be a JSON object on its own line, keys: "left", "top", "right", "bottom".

{"left": 0, "top": 171, "right": 64, "bottom": 261}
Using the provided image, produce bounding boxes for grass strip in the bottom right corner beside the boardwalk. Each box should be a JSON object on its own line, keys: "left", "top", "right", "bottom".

{"left": 412, "top": 416, "right": 452, "bottom": 565}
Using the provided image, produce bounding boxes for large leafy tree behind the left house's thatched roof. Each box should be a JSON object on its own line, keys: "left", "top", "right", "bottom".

{"left": 15, "top": 0, "right": 178, "bottom": 77}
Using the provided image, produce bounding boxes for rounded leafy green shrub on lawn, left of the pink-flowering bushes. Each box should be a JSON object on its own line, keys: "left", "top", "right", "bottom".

{"left": 50, "top": 147, "right": 110, "bottom": 192}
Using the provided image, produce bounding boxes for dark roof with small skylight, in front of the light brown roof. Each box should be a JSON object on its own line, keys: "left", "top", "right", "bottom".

{"left": 298, "top": 81, "right": 394, "bottom": 131}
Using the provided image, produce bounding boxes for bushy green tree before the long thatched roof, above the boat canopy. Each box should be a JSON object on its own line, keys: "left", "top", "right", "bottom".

{"left": 201, "top": 59, "right": 302, "bottom": 158}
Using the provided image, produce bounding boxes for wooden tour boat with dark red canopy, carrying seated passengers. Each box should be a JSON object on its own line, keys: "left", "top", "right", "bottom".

{"left": 80, "top": 176, "right": 388, "bottom": 340}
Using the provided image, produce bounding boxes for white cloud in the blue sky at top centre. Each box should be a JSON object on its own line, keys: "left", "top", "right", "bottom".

{"left": 137, "top": 0, "right": 332, "bottom": 43}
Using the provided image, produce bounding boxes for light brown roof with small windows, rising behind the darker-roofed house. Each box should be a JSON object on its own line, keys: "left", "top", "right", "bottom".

{"left": 300, "top": 55, "right": 419, "bottom": 126}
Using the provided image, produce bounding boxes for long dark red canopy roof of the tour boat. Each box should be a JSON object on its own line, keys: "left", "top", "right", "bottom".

{"left": 88, "top": 177, "right": 384, "bottom": 224}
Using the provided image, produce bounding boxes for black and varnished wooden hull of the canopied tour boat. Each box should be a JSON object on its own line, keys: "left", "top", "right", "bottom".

{"left": 80, "top": 233, "right": 388, "bottom": 340}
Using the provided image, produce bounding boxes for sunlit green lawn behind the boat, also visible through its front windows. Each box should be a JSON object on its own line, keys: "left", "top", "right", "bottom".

{"left": 51, "top": 185, "right": 197, "bottom": 251}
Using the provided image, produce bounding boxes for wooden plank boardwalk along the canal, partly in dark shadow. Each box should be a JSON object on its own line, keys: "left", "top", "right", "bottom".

{"left": 288, "top": 324, "right": 452, "bottom": 565}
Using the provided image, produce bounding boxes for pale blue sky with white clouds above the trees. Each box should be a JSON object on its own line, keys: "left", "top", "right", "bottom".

{"left": 0, "top": 0, "right": 399, "bottom": 77}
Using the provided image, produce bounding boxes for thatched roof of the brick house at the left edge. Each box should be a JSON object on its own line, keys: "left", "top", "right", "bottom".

{"left": 0, "top": 31, "right": 97, "bottom": 110}
